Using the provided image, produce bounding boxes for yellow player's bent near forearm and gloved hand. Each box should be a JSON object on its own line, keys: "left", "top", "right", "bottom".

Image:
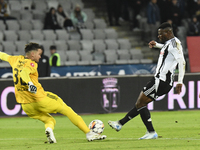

{"left": 20, "top": 67, "right": 37, "bottom": 93}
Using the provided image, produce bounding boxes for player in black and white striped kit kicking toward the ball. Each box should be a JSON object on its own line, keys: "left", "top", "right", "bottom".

{"left": 108, "top": 22, "right": 185, "bottom": 140}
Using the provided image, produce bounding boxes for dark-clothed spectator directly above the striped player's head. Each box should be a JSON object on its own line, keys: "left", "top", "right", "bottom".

{"left": 168, "top": 0, "right": 182, "bottom": 26}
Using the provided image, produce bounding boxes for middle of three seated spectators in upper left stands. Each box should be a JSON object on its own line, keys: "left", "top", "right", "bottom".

{"left": 56, "top": 5, "right": 74, "bottom": 31}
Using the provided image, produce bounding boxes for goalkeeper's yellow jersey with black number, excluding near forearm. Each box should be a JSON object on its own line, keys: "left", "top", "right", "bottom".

{"left": 4, "top": 53, "right": 46, "bottom": 103}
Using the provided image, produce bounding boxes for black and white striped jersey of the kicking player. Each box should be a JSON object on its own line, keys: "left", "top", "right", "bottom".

{"left": 155, "top": 37, "right": 185, "bottom": 85}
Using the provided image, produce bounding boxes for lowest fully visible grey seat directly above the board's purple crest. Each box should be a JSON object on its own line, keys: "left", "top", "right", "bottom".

{"left": 104, "top": 49, "right": 118, "bottom": 64}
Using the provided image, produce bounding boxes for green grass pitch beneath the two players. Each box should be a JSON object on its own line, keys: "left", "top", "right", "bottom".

{"left": 0, "top": 110, "right": 200, "bottom": 150}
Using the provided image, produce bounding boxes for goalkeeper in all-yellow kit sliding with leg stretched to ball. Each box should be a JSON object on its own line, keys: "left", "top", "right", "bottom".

{"left": 0, "top": 43, "right": 106, "bottom": 143}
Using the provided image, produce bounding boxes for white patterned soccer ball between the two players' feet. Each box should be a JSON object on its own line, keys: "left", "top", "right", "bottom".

{"left": 89, "top": 119, "right": 104, "bottom": 134}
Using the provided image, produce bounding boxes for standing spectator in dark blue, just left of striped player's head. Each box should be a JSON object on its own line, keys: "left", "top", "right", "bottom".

{"left": 147, "top": 0, "right": 160, "bottom": 40}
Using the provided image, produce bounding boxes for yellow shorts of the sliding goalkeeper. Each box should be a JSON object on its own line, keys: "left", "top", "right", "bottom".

{"left": 22, "top": 92, "right": 66, "bottom": 118}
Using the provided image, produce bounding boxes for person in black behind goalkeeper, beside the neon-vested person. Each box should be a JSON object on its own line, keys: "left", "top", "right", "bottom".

{"left": 38, "top": 46, "right": 51, "bottom": 77}
